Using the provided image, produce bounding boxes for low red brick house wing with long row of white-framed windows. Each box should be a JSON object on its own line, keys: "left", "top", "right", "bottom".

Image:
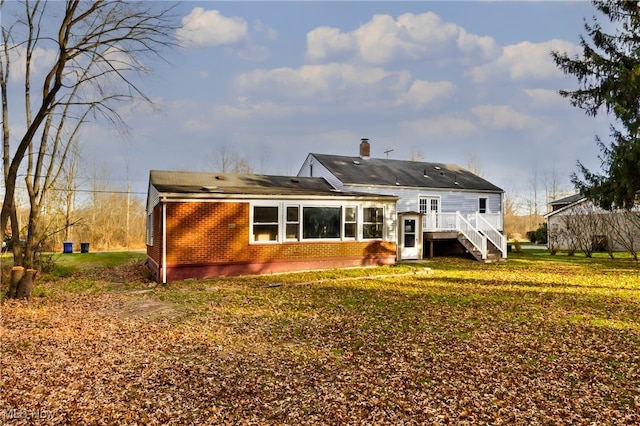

{"left": 146, "top": 170, "right": 398, "bottom": 283}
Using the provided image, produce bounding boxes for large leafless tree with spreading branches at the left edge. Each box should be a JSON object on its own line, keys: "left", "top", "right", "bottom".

{"left": 0, "top": 0, "right": 175, "bottom": 297}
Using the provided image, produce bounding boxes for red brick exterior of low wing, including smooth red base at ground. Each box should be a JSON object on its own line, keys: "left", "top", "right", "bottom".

{"left": 147, "top": 202, "right": 396, "bottom": 281}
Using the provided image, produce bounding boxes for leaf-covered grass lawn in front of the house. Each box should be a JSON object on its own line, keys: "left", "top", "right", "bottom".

{"left": 0, "top": 250, "right": 640, "bottom": 425}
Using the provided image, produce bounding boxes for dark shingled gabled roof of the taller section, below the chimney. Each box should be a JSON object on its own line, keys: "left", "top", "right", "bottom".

{"left": 310, "top": 154, "right": 503, "bottom": 192}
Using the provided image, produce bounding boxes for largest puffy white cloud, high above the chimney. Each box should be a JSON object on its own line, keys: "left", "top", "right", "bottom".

{"left": 307, "top": 12, "right": 499, "bottom": 65}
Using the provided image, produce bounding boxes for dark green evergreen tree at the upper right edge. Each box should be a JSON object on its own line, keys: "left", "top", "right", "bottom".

{"left": 552, "top": 0, "right": 640, "bottom": 210}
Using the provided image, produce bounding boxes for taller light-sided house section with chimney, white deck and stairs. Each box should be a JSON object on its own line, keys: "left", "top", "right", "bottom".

{"left": 298, "top": 139, "right": 507, "bottom": 261}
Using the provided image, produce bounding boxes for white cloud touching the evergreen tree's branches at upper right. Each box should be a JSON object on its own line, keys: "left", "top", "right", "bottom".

{"left": 468, "top": 40, "right": 578, "bottom": 83}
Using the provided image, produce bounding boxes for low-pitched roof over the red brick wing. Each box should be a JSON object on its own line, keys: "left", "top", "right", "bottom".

{"left": 149, "top": 170, "right": 397, "bottom": 200}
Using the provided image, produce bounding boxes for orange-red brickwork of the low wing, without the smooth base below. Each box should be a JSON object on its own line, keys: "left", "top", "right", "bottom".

{"left": 147, "top": 202, "right": 396, "bottom": 282}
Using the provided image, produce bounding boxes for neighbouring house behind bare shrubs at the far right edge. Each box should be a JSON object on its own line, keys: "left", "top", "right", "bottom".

{"left": 544, "top": 194, "right": 640, "bottom": 253}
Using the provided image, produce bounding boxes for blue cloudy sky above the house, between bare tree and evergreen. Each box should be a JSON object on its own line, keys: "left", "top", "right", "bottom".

{"left": 1, "top": 1, "right": 611, "bottom": 209}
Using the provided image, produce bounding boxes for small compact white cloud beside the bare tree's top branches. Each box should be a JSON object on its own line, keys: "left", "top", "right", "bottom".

{"left": 176, "top": 7, "right": 248, "bottom": 47}
